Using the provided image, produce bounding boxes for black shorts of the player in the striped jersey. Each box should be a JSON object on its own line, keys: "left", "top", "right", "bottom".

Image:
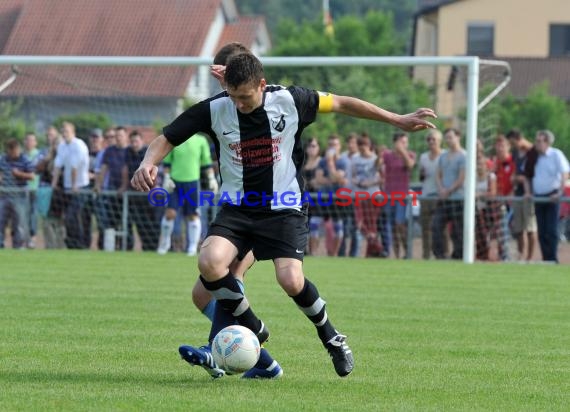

{"left": 208, "top": 205, "right": 309, "bottom": 261}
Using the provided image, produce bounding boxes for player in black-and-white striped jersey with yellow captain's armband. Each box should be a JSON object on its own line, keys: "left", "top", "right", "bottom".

{"left": 132, "top": 53, "right": 435, "bottom": 376}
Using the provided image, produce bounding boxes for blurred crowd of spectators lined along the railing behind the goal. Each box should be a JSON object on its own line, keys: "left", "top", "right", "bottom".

{"left": 0, "top": 123, "right": 570, "bottom": 261}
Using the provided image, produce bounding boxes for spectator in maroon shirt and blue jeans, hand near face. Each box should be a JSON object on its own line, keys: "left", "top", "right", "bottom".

{"left": 384, "top": 132, "right": 416, "bottom": 259}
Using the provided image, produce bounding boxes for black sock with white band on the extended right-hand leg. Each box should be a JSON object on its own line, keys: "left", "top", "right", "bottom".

{"left": 291, "top": 278, "right": 337, "bottom": 344}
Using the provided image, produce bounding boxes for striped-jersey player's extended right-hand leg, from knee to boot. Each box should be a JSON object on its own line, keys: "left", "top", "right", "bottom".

{"left": 274, "top": 258, "right": 354, "bottom": 376}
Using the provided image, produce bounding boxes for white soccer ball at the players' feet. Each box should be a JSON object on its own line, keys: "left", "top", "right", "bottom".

{"left": 212, "top": 325, "right": 260, "bottom": 374}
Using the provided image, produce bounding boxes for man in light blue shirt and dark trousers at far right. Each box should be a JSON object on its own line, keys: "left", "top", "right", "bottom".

{"left": 532, "top": 130, "right": 570, "bottom": 263}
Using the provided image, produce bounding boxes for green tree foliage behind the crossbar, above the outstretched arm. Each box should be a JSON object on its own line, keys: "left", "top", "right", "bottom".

{"left": 266, "top": 11, "right": 431, "bottom": 143}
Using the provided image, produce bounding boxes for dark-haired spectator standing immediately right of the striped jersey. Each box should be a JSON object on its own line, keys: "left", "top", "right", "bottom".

{"left": 302, "top": 137, "right": 323, "bottom": 255}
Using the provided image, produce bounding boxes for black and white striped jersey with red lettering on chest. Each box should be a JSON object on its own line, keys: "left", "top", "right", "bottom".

{"left": 163, "top": 85, "right": 319, "bottom": 210}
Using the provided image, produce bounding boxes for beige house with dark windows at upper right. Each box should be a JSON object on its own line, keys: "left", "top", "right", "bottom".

{"left": 412, "top": 0, "right": 570, "bottom": 118}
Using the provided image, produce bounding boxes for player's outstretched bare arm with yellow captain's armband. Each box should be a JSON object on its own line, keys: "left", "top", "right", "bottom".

{"left": 319, "top": 93, "right": 437, "bottom": 132}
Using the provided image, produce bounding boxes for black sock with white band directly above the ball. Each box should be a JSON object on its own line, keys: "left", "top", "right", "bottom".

{"left": 200, "top": 273, "right": 262, "bottom": 336}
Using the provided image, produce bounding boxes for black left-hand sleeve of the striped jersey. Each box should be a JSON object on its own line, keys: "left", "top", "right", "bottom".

{"left": 162, "top": 99, "right": 213, "bottom": 146}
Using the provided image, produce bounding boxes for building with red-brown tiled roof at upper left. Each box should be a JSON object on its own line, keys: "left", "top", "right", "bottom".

{"left": 0, "top": 0, "right": 271, "bottom": 136}
